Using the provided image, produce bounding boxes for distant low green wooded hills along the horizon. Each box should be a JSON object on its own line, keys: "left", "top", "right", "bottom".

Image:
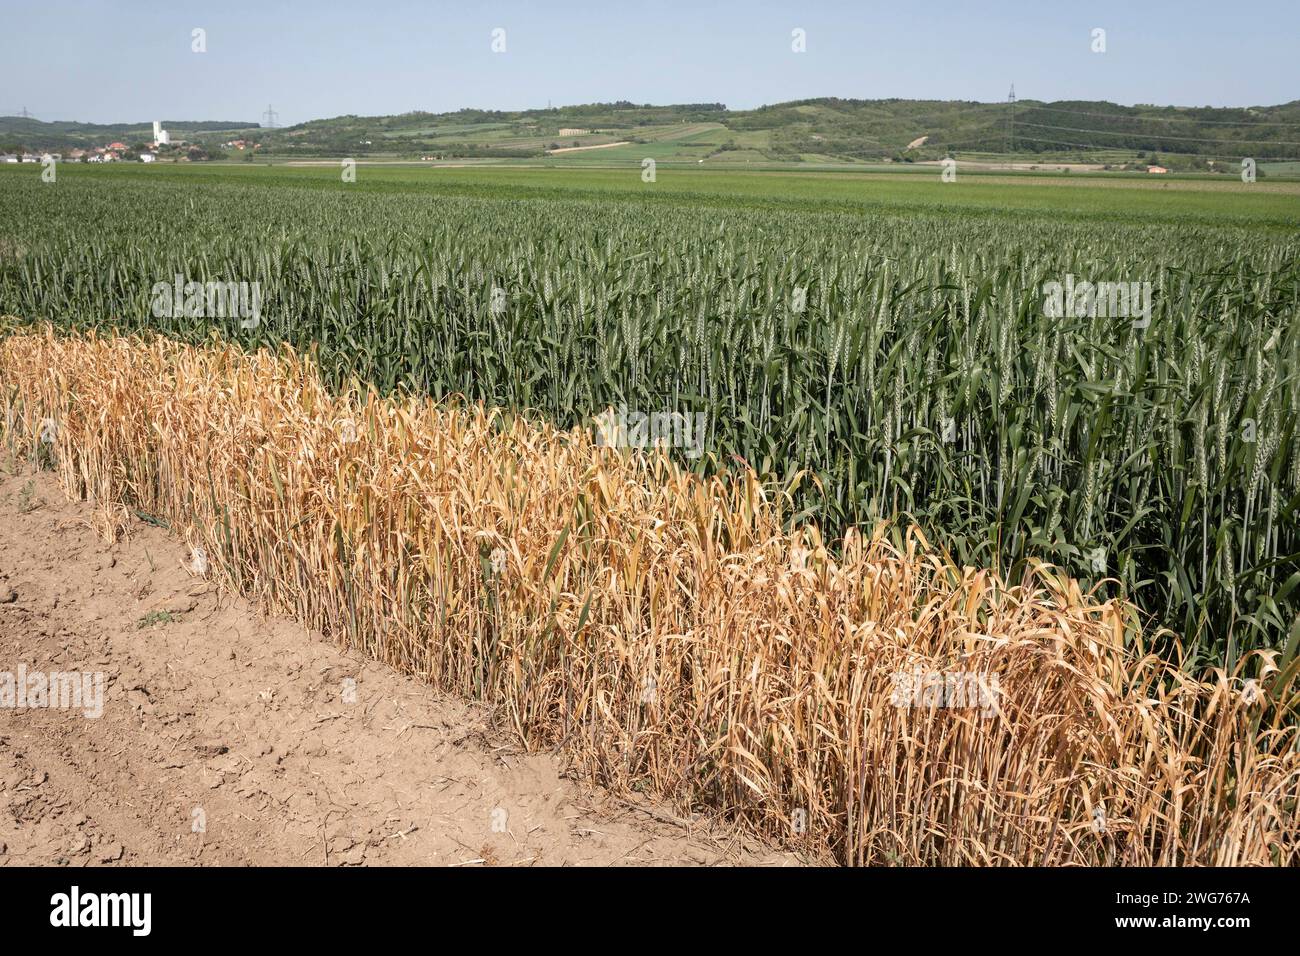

{"left": 0, "top": 98, "right": 1300, "bottom": 168}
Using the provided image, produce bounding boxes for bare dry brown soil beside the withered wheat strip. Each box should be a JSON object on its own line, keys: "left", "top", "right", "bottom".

{"left": 0, "top": 472, "right": 798, "bottom": 866}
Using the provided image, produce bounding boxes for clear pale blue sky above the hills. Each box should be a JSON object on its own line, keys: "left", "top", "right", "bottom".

{"left": 0, "top": 0, "right": 1300, "bottom": 125}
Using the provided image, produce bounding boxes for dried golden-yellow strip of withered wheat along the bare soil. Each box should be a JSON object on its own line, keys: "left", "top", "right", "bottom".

{"left": 0, "top": 328, "right": 1300, "bottom": 865}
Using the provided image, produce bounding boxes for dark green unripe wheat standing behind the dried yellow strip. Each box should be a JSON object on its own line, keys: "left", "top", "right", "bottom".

{"left": 0, "top": 169, "right": 1300, "bottom": 672}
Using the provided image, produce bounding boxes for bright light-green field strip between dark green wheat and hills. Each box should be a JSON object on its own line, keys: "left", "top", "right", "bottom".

{"left": 12, "top": 160, "right": 1300, "bottom": 229}
